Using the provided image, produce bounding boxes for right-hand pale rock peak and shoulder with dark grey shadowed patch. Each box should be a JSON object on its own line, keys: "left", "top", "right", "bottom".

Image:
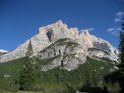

{"left": 79, "top": 30, "right": 119, "bottom": 62}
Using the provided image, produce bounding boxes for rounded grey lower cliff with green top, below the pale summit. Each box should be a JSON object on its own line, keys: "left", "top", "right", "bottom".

{"left": 37, "top": 38, "right": 87, "bottom": 71}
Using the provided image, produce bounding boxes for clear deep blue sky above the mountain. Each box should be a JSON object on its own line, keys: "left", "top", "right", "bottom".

{"left": 0, "top": 0, "right": 124, "bottom": 50}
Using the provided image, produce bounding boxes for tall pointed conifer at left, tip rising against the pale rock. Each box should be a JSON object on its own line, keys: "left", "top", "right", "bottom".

{"left": 19, "top": 41, "right": 34, "bottom": 90}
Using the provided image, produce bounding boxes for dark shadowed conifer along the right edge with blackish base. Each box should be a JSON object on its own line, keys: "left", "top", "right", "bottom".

{"left": 105, "top": 18, "right": 124, "bottom": 93}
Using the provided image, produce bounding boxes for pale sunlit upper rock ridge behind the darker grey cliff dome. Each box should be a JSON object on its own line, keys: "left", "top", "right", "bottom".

{"left": 0, "top": 20, "right": 118, "bottom": 64}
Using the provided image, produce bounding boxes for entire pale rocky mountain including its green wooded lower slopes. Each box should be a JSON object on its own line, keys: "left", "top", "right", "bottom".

{"left": 0, "top": 21, "right": 119, "bottom": 93}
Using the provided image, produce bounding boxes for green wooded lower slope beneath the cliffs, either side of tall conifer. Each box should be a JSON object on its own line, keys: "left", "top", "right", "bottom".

{"left": 0, "top": 58, "right": 114, "bottom": 93}
